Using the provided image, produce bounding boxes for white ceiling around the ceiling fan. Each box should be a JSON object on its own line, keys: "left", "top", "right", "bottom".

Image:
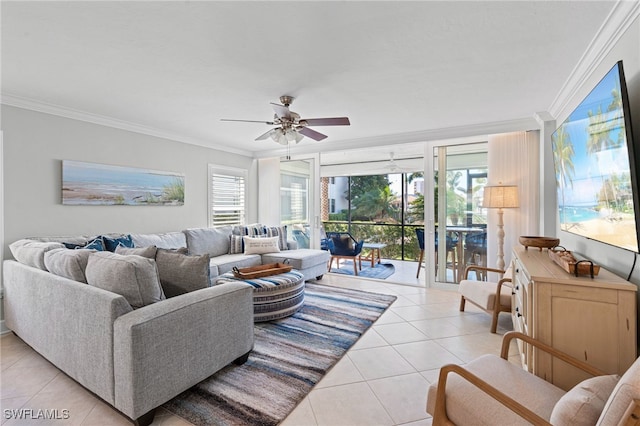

{"left": 0, "top": 1, "right": 614, "bottom": 161}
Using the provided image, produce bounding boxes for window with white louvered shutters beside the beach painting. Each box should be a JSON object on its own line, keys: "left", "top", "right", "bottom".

{"left": 209, "top": 165, "right": 247, "bottom": 226}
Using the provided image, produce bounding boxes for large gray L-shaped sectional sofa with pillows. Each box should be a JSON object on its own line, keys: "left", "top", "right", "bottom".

{"left": 3, "top": 228, "right": 329, "bottom": 424}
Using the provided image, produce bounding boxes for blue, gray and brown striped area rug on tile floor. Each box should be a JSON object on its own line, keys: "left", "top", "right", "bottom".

{"left": 164, "top": 283, "right": 396, "bottom": 425}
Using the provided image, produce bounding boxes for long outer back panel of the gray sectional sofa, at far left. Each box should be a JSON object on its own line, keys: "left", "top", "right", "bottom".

{"left": 3, "top": 260, "right": 132, "bottom": 404}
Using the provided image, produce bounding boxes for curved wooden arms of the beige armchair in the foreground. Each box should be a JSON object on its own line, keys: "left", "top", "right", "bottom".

{"left": 433, "top": 331, "right": 608, "bottom": 426}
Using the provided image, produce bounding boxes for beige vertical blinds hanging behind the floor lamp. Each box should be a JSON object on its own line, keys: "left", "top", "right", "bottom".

{"left": 487, "top": 131, "right": 540, "bottom": 268}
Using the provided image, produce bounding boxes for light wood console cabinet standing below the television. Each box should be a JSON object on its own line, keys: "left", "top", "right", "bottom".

{"left": 511, "top": 247, "right": 638, "bottom": 390}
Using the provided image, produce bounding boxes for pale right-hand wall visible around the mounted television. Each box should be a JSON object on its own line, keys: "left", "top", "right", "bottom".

{"left": 544, "top": 14, "right": 640, "bottom": 284}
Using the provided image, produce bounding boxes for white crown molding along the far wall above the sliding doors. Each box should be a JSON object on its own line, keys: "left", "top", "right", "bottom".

{"left": 255, "top": 116, "right": 540, "bottom": 158}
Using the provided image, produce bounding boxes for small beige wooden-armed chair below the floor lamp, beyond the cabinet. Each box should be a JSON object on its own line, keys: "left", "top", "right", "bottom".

{"left": 458, "top": 265, "right": 513, "bottom": 333}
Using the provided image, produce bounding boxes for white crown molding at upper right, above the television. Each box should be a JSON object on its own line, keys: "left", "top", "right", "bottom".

{"left": 548, "top": 0, "right": 640, "bottom": 118}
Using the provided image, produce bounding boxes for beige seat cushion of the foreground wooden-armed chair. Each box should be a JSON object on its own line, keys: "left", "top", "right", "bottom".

{"left": 427, "top": 355, "right": 565, "bottom": 426}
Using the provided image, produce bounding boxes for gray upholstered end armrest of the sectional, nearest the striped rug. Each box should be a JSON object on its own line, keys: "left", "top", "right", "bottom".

{"left": 114, "top": 283, "right": 253, "bottom": 419}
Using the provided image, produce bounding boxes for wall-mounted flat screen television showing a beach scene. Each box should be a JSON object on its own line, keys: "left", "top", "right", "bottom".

{"left": 551, "top": 61, "right": 640, "bottom": 253}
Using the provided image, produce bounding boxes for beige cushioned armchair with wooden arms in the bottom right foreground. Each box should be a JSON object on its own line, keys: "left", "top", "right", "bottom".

{"left": 427, "top": 331, "right": 640, "bottom": 426}
